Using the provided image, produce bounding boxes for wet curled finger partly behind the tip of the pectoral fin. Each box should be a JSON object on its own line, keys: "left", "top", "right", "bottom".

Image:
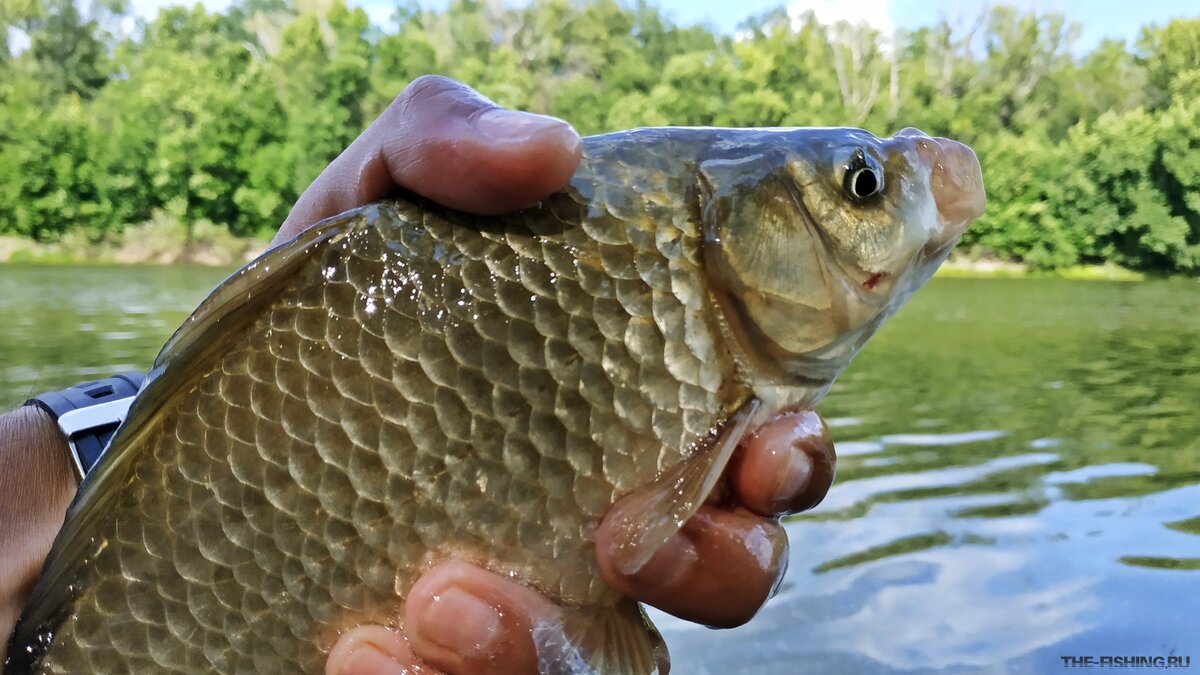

{"left": 595, "top": 500, "right": 787, "bottom": 628}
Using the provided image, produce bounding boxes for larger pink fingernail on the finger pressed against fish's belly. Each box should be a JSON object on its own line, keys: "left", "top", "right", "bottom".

{"left": 419, "top": 586, "right": 500, "bottom": 658}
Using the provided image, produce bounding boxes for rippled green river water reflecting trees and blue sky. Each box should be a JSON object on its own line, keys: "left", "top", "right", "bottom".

{"left": 0, "top": 265, "right": 1200, "bottom": 675}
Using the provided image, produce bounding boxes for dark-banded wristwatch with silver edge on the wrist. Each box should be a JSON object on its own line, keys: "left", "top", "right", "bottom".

{"left": 25, "top": 372, "right": 144, "bottom": 480}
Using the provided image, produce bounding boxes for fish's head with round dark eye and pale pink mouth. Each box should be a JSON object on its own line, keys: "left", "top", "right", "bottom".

{"left": 698, "top": 129, "right": 984, "bottom": 387}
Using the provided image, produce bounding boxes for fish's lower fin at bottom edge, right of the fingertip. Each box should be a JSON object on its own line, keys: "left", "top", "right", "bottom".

{"left": 533, "top": 598, "right": 671, "bottom": 675}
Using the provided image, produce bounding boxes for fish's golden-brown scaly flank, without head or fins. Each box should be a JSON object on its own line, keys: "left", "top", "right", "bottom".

{"left": 40, "top": 140, "right": 739, "bottom": 673}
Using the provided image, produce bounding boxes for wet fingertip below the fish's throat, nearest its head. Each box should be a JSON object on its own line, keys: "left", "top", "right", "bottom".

{"left": 728, "top": 411, "right": 838, "bottom": 516}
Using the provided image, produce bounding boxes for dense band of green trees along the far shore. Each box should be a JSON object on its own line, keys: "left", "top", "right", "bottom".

{"left": 0, "top": 0, "right": 1200, "bottom": 274}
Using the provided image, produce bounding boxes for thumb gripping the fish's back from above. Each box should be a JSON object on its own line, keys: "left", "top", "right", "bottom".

{"left": 275, "top": 76, "right": 582, "bottom": 243}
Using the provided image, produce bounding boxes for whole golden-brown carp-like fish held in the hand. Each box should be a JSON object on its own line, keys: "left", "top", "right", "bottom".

{"left": 5, "top": 127, "right": 984, "bottom": 675}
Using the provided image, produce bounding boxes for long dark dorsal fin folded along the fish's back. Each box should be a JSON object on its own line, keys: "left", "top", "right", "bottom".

{"left": 11, "top": 207, "right": 360, "bottom": 645}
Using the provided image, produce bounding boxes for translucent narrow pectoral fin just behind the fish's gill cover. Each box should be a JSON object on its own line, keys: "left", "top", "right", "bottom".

{"left": 605, "top": 398, "right": 761, "bottom": 575}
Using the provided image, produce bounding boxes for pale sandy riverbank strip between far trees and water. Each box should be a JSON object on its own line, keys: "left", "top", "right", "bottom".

{"left": 0, "top": 225, "right": 1147, "bottom": 281}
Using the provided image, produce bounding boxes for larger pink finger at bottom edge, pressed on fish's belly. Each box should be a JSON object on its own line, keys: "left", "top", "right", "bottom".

{"left": 404, "top": 562, "right": 560, "bottom": 675}
